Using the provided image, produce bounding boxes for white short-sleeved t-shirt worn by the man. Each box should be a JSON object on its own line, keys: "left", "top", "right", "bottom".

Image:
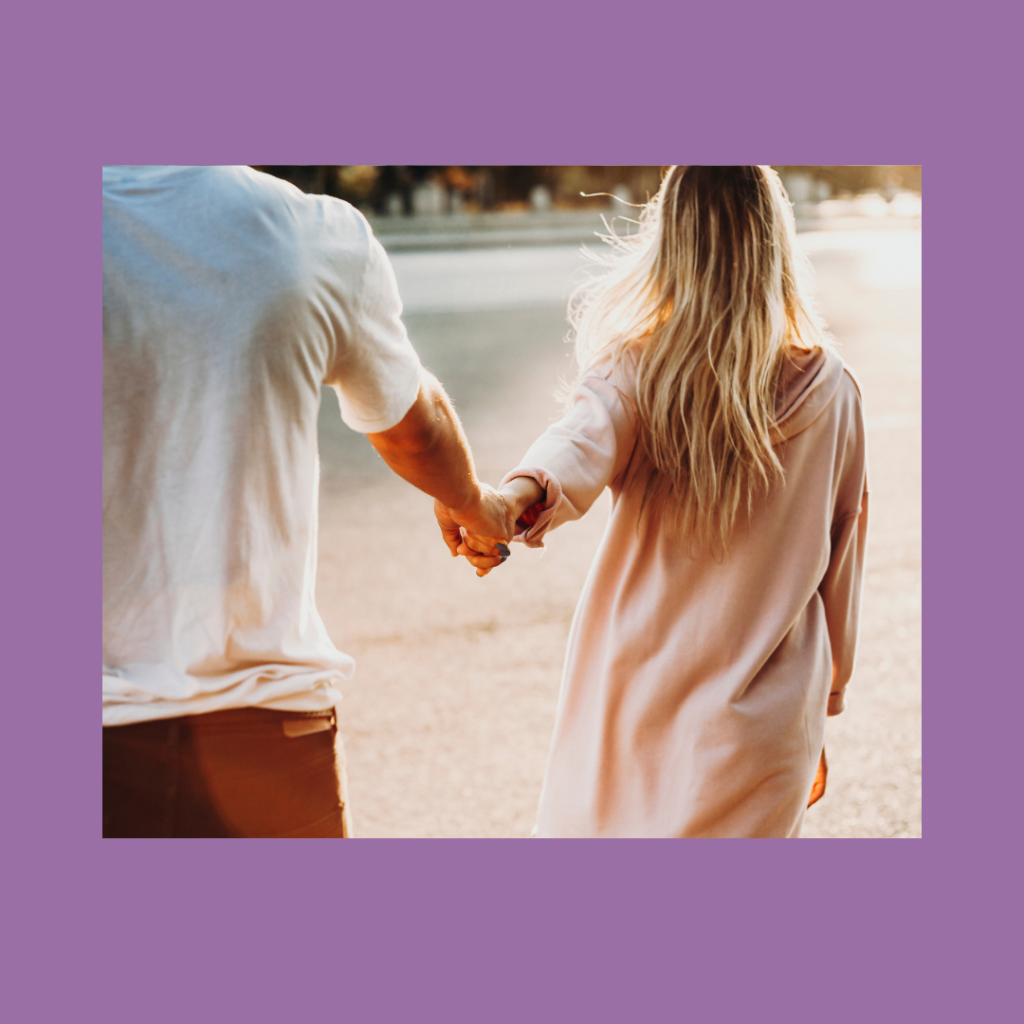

{"left": 103, "top": 167, "right": 421, "bottom": 725}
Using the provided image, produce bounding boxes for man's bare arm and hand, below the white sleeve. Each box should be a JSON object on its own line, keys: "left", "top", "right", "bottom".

{"left": 367, "top": 371, "right": 513, "bottom": 556}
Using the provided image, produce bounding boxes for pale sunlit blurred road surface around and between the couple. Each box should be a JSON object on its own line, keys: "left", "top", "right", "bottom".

{"left": 316, "top": 228, "right": 921, "bottom": 838}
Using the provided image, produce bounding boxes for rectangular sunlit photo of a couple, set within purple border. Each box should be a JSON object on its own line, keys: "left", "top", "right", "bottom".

{"left": 102, "top": 164, "right": 923, "bottom": 839}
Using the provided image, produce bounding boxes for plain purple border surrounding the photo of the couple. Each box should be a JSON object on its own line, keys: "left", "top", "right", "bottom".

{"left": 6, "top": 2, "right": 1007, "bottom": 1022}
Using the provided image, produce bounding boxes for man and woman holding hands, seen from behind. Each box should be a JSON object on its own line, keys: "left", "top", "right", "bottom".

{"left": 103, "top": 166, "right": 867, "bottom": 838}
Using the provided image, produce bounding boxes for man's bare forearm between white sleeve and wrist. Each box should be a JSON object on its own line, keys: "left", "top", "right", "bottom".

{"left": 367, "top": 372, "right": 480, "bottom": 509}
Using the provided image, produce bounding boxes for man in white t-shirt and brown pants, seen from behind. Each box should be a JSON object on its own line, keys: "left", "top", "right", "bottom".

{"left": 103, "top": 167, "right": 511, "bottom": 837}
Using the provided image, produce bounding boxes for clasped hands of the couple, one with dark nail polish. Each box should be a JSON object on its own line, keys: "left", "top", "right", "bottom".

{"left": 434, "top": 477, "right": 544, "bottom": 577}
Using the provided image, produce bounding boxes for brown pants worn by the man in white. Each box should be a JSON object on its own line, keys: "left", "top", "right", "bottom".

{"left": 103, "top": 708, "right": 349, "bottom": 839}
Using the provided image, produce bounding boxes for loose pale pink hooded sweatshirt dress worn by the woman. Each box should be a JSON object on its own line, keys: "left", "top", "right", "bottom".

{"left": 506, "top": 348, "right": 867, "bottom": 838}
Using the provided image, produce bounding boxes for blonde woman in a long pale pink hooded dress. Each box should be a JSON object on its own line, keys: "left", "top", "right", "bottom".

{"left": 458, "top": 167, "right": 867, "bottom": 837}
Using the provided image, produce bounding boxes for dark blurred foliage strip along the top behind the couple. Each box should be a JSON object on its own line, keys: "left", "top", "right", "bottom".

{"left": 257, "top": 164, "right": 921, "bottom": 216}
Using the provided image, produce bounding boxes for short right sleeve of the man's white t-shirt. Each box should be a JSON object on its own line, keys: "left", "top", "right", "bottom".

{"left": 325, "top": 216, "right": 422, "bottom": 434}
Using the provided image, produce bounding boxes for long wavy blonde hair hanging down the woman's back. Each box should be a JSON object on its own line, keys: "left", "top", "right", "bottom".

{"left": 570, "top": 166, "right": 825, "bottom": 550}
